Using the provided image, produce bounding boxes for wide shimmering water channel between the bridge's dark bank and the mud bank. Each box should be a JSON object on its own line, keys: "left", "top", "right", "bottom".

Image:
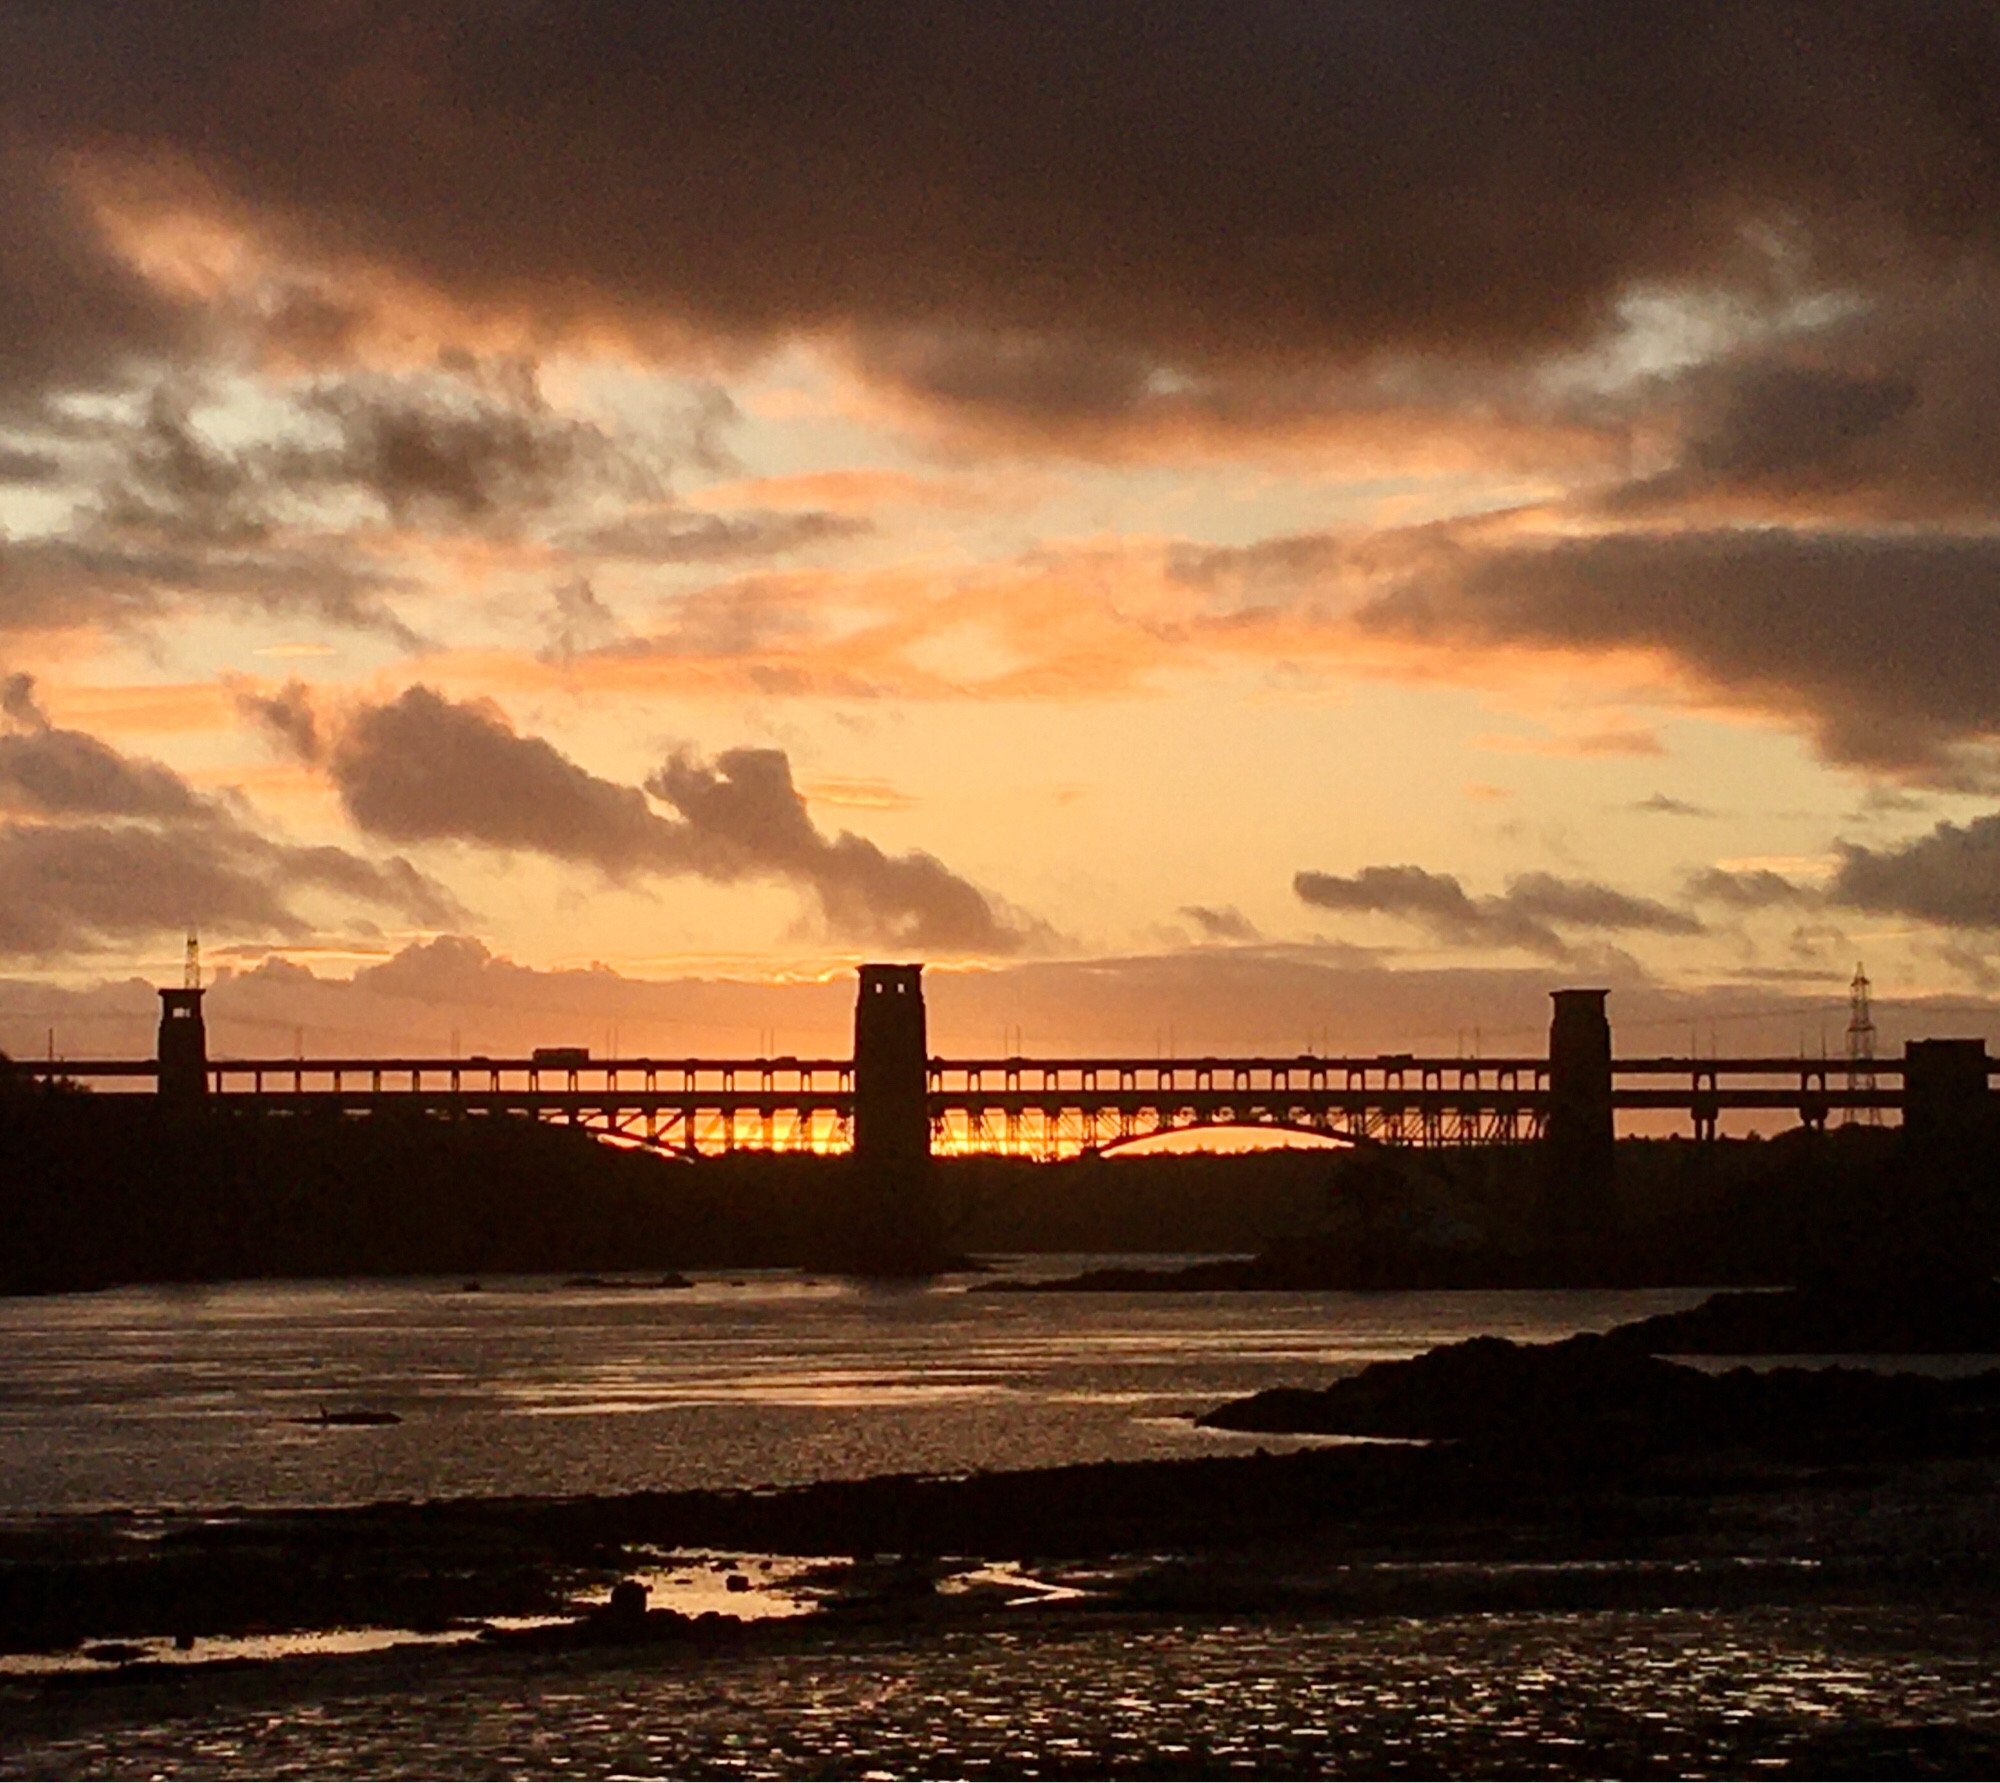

{"left": 0, "top": 1257, "right": 1702, "bottom": 1515}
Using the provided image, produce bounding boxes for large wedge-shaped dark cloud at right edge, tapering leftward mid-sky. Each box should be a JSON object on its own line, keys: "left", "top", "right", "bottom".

{"left": 1358, "top": 528, "right": 2000, "bottom": 784}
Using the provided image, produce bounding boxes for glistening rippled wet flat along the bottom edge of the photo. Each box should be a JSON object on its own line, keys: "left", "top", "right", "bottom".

{"left": 11, "top": 1607, "right": 2000, "bottom": 1777}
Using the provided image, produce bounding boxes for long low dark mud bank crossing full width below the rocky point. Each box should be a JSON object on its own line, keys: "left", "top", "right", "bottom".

{"left": 0, "top": 1391, "right": 2000, "bottom": 1653}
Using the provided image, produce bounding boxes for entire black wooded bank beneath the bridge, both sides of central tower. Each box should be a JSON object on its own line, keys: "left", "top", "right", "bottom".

{"left": 0, "top": 1091, "right": 1996, "bottom": 1293}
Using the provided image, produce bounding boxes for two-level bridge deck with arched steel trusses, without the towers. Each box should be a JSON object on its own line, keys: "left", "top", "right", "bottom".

{"left": 12, "top": 1053, "right": 1920, "bottom": 1155}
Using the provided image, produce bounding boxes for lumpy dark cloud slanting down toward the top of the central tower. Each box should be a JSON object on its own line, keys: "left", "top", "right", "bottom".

{"left": 330, "top": 688, "right": 1034, "bottom": 953}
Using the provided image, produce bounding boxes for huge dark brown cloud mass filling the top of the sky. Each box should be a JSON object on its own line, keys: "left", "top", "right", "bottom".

{"left": 0, "top": 0, "right": 2000, "bottom": 404}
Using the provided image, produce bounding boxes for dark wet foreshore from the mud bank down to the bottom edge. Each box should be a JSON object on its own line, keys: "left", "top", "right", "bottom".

{"left": 0, "top": 1445, "right": 2000, "bottom": 1777}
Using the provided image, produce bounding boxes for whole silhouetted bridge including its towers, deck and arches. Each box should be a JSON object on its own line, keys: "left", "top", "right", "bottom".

{"left": 12, "top": 965, "right": 1996, "bottom": 1173}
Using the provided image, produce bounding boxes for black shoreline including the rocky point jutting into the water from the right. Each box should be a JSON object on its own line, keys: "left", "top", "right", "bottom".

{"left": 11, "top": 1281, "right": 2000, "bottom": 1653}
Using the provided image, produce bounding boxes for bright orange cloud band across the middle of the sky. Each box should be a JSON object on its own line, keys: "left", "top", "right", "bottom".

{"left": 378, "top": 540, "right": 1692, "bottom": 731}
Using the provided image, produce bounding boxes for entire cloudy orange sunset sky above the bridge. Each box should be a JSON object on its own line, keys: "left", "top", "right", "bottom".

{"left": 0, "top": 0, "right": 2000, "bottom": 1057}
